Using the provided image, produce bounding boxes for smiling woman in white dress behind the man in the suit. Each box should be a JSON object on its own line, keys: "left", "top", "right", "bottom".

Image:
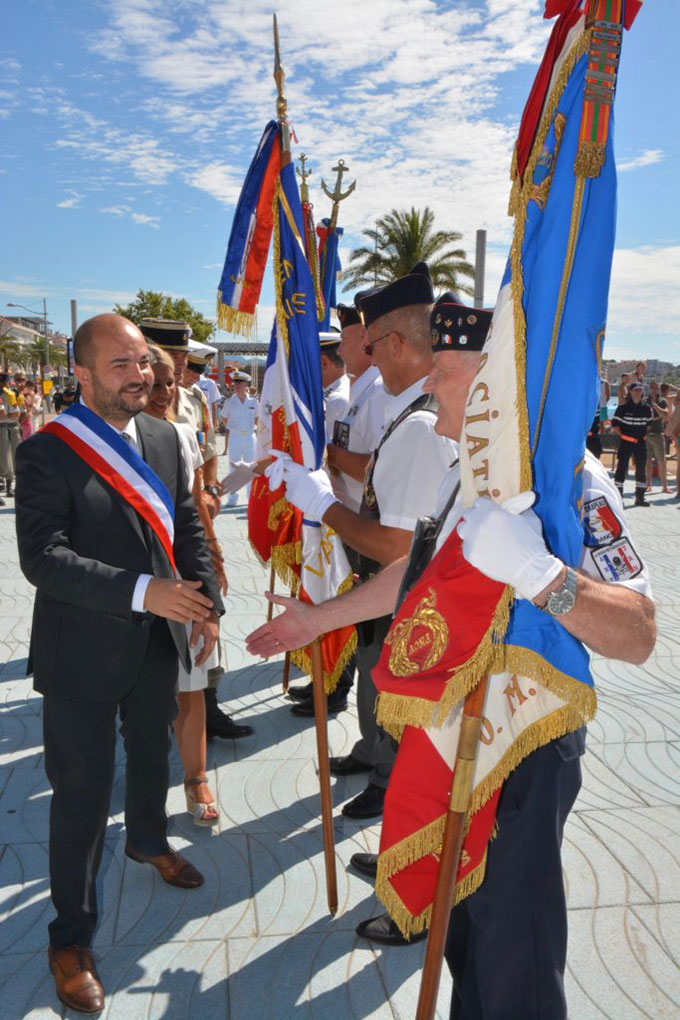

{"left": 145, "top": 344, "right": 226, "bottom": 825}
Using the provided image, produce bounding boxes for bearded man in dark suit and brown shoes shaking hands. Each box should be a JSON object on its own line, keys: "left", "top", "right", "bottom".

{"left": 16, "top": 314, "right": 223, "bottom": 1013}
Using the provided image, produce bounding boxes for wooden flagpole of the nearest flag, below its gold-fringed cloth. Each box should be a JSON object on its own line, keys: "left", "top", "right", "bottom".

{"left": 416, "top": 676, "right": 488, "bottom": 1020}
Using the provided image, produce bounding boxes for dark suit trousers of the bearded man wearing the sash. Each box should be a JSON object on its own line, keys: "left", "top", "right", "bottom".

{"left": 43, "top": 619, "right": 177, "bottom": 949}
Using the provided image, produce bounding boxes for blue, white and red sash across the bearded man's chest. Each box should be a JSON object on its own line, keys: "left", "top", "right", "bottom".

{"left": 41, "top": 403, "right": 177, "bottom": 573}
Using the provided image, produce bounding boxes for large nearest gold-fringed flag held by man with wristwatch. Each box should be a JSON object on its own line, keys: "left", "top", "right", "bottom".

{"left": 372, "top": 0, "right": 639, "bottom": 934}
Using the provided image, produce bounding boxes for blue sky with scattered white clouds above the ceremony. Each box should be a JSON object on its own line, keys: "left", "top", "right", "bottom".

{"left": 0, "top": 0, "right": 680, "bottom": 363}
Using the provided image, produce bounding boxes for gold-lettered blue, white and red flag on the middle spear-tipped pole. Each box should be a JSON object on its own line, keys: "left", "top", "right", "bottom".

{"left": 248, "top": 163, "right": 356, "bottom": 693}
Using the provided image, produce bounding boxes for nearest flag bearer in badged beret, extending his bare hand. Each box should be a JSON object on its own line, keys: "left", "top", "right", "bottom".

{"left": 248, "top": 294, "right": 656, "bottom": 1003}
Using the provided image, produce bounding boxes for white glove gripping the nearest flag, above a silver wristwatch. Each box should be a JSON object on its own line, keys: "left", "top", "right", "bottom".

{"left": 458, "top": 493, "right": 564, "bottom": 600}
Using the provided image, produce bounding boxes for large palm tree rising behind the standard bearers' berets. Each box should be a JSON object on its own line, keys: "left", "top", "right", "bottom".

{"left": 344, "top": 206, "right": 474, "bottom": 295}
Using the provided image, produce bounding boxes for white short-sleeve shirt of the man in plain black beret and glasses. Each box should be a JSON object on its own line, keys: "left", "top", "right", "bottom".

{"left": 373, "top": 376, "right": 458, "bottom": 531}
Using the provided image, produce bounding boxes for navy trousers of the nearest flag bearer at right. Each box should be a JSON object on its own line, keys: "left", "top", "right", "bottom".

{"left": 446, "top": 730, "right": 585, "bottom": 1020}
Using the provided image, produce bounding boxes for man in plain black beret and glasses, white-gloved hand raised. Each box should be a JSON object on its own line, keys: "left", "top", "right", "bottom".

{"left": 263, "top": 262, "right": 456, "bottom": 819}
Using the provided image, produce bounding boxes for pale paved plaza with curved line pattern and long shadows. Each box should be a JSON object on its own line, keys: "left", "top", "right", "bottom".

{"left": 0, "top": 456, "right": 680, "bottom": 1020}
